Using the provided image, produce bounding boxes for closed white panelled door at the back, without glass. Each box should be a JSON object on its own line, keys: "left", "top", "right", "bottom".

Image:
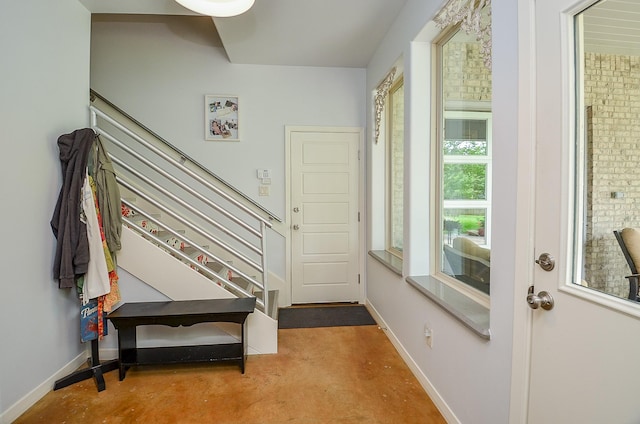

{"left": 290, "top": 131, "right": 360, "bottom": 303}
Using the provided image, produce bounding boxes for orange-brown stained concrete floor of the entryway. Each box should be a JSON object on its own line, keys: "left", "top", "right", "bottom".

{"left": 14, "top": 325, "right": 445, "bottom": 424}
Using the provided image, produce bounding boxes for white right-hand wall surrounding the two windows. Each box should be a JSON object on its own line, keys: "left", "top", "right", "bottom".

{"left": 366, "top": 0, "right": 524, "bottom": 423}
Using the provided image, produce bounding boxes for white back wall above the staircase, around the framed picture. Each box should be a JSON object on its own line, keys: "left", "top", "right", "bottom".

{"left": 91, "top": 16, "right": 366, "bottom": 218}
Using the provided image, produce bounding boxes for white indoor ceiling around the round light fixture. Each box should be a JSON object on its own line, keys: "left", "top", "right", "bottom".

{"left": 80, "top": 0, "right": 406, "bottom": 68}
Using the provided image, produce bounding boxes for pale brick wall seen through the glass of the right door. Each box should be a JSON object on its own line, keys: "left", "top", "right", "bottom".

{"left": 584, "top": 53, "right": 640, "bottom": 298}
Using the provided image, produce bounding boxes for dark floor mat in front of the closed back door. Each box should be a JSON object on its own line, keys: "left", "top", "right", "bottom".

{"left": 278, "top": 305, "right": 376, "bottom": 329}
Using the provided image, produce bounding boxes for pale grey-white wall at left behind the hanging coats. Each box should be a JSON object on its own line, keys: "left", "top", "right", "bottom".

{"left": 0, "top": 0, "right": 90, "bottom": 423}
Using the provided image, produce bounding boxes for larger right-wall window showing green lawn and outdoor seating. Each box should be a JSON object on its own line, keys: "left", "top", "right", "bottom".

{"left": 435, "top": 25, "right": 492, "bottom": 297}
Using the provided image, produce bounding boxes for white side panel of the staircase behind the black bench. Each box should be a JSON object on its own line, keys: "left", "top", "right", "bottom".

{"left": 118, "top": 226, "right": 278, "bottom": 354}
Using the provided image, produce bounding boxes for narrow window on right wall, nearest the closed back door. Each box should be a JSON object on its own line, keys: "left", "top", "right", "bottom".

{"left": 386, "top": 77, "right": 404, "bottom": 257}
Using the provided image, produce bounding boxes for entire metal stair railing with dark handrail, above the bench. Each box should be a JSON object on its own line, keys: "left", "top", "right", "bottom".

{"left": 90, "top": 93, "right": 280, "bottom": 313}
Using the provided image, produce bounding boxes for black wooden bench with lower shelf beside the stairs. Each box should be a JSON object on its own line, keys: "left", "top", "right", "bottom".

{"left": 107, "top": 297, "right": 256, "bottom": 381}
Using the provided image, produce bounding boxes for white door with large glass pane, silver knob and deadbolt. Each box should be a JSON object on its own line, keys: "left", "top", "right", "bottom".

{"left": 522, "top": 0, "right": 640, "bottom": 424}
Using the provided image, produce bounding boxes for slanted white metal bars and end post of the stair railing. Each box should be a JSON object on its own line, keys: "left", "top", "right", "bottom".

{"left": 89, "top": 97, "right": 277, "bottom": 313}
